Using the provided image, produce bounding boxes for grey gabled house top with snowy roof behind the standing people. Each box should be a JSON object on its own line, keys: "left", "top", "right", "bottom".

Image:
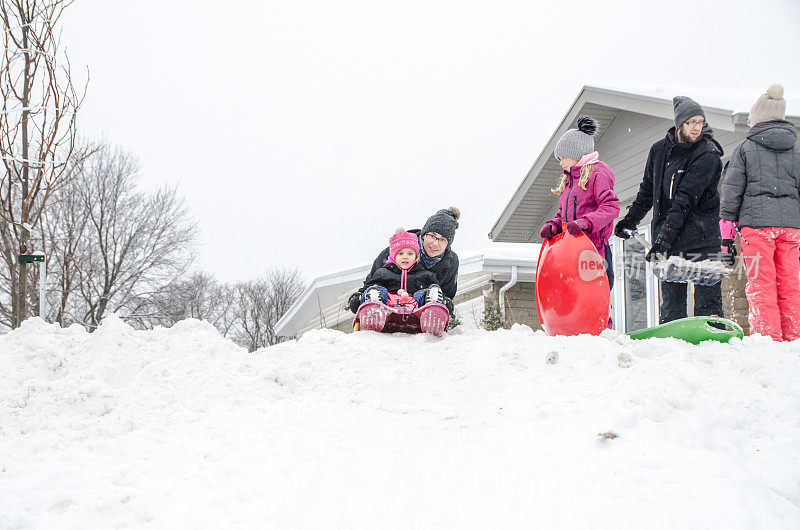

{"left": 489, "top": 86, "right": 800, "bottom": 242}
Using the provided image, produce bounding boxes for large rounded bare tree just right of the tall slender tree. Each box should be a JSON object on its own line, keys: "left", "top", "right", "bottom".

{"left": 70, "top": 143, "right": 197, "bottom": 327}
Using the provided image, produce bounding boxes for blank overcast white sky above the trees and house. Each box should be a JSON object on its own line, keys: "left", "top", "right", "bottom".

{"left": 62, "top": 0, "right": 800, "bottom": 280}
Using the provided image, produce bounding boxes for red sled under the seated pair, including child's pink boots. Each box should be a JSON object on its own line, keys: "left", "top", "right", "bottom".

{"left": 353, "top": 295, "right": 450, "bottom": 337}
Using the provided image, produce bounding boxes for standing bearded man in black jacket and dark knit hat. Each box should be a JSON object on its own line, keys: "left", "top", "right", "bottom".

{"left": 614, "top": 96, "right": 723, "bottom": 324}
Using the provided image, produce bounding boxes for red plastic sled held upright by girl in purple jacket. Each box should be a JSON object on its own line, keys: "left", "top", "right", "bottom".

{"left": 536, "top": 223, "right": 611, "bottom": 335}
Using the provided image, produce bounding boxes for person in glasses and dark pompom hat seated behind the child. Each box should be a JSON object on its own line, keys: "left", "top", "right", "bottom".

{"left": 349, "top": 206, "right": 461, "bottom": 313}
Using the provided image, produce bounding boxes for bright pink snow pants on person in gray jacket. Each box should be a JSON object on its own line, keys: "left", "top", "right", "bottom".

{"left": 741, "top": 227, "right": 800, "bottom": 340}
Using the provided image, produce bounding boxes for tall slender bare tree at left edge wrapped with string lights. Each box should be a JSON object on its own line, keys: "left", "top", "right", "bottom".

{"left": 0, "top": 0, "right": 88, "bottom": 327}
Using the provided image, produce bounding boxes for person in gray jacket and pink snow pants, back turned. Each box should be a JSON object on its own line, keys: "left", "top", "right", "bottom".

{"left": 720, "top": 85, "right": 800, "bottom": 340}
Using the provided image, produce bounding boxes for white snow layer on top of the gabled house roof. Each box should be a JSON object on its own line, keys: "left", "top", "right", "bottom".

{"left": 591, "top": 84, "right": 800, "bottom": 116}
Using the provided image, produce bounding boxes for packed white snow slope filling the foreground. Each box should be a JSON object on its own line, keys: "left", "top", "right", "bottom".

{"left": 0, "top": 317, "right": 800, "bottom": 529}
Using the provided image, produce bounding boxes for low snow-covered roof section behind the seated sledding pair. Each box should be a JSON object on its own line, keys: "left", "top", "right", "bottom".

{"left": 275, "top": 243, "right": 539, "bottom": 337}
